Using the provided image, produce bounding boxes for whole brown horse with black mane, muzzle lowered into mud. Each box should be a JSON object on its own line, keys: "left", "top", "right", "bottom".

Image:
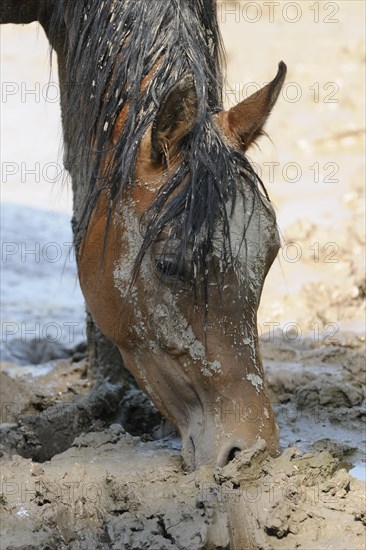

{"left": 0, "top": 0, "right": 286, "bottom": 470}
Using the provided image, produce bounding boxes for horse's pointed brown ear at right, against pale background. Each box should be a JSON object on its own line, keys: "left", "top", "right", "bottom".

{"left": 228, "top": 61, "right": 287, "bottom": 149}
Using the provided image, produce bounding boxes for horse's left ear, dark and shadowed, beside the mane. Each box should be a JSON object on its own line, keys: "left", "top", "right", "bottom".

{"left": 151, "top": 76, "right": 198, "bottom": 162}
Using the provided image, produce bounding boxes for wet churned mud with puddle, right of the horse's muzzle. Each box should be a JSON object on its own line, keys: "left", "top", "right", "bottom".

{"left": 261, "top": 334, "right": 366, "bottom": 460}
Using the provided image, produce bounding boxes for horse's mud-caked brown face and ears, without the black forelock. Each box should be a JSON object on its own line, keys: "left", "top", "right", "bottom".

{"left": 79, "top": 63, "right": 286, "bottom": 468}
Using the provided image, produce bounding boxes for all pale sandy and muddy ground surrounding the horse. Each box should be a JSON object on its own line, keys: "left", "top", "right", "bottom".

{"left": 0, "top": 0, "right": 366, "bottom": 550}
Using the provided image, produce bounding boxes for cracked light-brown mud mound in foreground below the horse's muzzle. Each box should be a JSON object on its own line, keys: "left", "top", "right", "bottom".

{"left": 1, "top": 436, "right": 365, "bottom": 550}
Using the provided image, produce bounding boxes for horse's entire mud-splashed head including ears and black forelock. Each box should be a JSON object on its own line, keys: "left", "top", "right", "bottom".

{"left": 79, "top": 63, "right": 286, "bottom": 468}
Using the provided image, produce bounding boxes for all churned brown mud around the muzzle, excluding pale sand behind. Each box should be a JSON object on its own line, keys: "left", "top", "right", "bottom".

{"left": 0, "top": 335, "right": 365, "bottom": 550}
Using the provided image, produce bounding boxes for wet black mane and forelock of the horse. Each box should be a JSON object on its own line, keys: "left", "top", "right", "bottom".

{"left": 51, "top": 0, "right": 268, "bottom": 296}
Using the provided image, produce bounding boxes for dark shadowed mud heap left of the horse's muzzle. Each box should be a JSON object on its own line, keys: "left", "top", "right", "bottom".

{"left": 0, "top": 359, "right": 161, "bottom": 462}
